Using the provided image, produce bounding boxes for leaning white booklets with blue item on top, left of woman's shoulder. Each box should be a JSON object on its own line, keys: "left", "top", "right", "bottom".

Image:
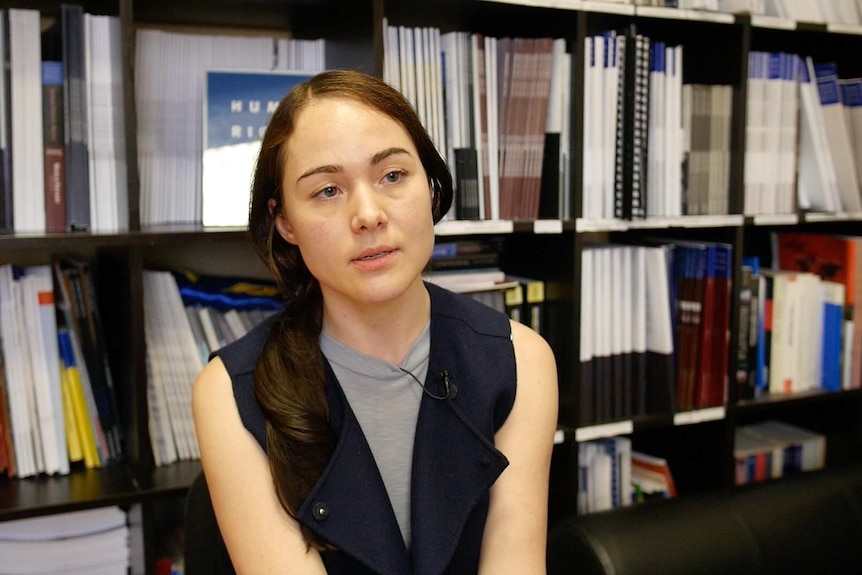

{"left": 144, "top": 270, "right": 281, "bottom": 465}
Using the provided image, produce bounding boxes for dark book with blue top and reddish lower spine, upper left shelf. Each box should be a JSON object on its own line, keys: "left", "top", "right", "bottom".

{"left": 42, "top": 61, "right": 66, "bottom": 232}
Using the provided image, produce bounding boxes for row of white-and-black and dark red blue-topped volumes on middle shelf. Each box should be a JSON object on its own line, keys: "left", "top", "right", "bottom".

{"left": 579, "top": 240, "right": 732, "bottom": 425}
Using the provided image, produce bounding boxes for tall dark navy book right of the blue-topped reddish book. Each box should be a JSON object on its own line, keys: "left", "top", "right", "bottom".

{"left": 60, "top": 4, "right": 90, "bottom": 231}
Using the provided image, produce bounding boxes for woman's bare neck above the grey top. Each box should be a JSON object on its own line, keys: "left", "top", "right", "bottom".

{"left": 323, "top": 281, "right": 431, "bottom": 365}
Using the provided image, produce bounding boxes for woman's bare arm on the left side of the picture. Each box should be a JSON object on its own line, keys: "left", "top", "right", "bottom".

{"left": 192, "top": 358, "right": 326, "bottom": 575}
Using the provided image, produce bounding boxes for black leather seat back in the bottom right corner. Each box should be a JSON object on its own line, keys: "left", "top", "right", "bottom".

{"left": 548, "top": 467, "right": 862, "bottom": 575}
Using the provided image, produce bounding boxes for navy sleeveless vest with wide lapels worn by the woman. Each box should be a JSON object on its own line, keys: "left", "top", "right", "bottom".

{"left": 217, "top": 284, "right": 516, "bottom": 575}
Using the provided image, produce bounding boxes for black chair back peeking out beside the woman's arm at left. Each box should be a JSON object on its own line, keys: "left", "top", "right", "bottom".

{"left": 185, "top": 473, "right": 235, "bottom": 575}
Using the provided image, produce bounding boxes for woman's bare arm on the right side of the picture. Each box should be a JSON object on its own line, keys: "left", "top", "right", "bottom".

{"left": 479, "top": 322, "right": 558, "bottom": 575}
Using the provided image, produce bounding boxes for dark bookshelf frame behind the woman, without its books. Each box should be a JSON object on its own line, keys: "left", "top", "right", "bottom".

{"left": 0, "top": 0, "right": 862, "bottom": 573}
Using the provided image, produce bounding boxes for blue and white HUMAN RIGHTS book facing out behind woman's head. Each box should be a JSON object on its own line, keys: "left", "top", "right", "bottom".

{"left": 202, "top": 70, "right": 315, "bottom": 227}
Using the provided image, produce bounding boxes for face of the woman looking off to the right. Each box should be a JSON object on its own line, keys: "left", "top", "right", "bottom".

{"left": 276, "top": 97, "right": 434, "bottom": 305}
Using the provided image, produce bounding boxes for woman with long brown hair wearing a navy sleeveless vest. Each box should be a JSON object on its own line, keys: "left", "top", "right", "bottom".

{"left": 193, "top": 71, "right": 557, "bottom": 575}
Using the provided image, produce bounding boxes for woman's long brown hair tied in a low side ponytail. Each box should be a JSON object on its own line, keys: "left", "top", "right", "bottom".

{"left": 249, "top": 70, "right": 452, "bottom": 549}
